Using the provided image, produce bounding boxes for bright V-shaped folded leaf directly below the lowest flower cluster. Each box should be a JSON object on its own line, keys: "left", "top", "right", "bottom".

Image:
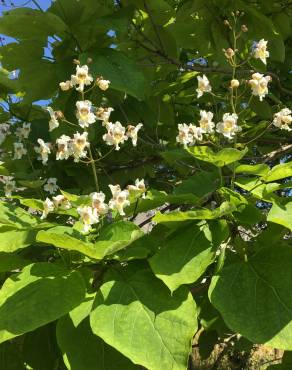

{"left": 37, "top": 221, "right": 144, "bottom": 260}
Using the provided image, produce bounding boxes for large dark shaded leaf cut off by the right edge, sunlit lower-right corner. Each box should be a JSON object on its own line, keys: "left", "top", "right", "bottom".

{"left": 209, "top": 243, "right": 292, "bottom": 350}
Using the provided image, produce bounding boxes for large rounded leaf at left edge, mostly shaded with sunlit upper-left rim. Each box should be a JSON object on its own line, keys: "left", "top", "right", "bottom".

{"left": 0, "top": 262, "right": 85, "bottom": 343}
